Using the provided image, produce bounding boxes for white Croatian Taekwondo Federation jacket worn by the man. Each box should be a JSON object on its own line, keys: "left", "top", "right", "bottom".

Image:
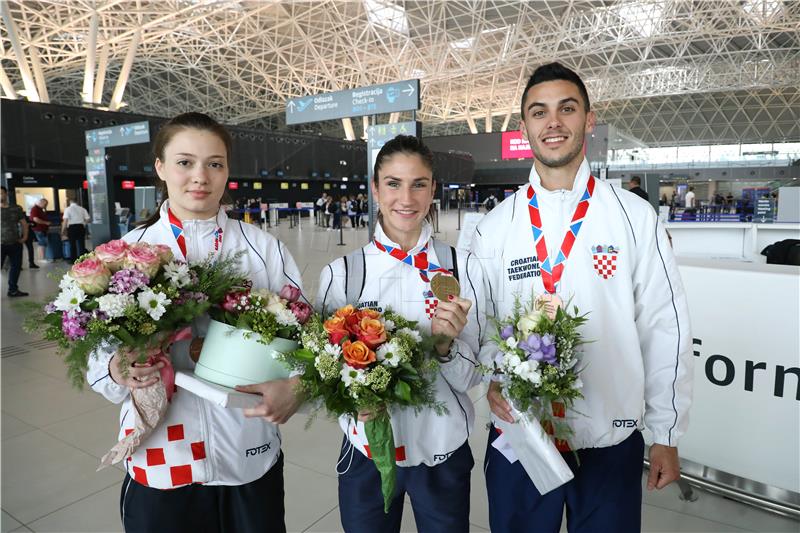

{"left": 471, "top": 160, "right": 693, "bottom": 449}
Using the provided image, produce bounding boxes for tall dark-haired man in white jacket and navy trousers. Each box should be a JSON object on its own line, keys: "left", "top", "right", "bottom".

{"left": 472, "top": 63, "right": 692, "bottom": 532}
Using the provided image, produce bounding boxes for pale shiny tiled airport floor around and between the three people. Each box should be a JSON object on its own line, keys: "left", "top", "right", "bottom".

{"left": 0, "top": 215, "right": 799, "bottom": 533}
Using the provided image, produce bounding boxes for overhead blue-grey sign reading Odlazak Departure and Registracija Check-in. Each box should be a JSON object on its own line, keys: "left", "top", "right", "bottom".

{"left": 286, "top": 80, "right": 420, "bottom": 124}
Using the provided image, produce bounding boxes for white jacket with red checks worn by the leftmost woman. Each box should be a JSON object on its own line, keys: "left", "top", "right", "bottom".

{"left": 87, "top": 202, "right": 302, "bottom": 489}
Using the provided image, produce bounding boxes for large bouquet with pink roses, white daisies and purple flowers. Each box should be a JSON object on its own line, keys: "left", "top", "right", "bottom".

{"left": 25, "top": 240, "right": 245, "bottom": 386}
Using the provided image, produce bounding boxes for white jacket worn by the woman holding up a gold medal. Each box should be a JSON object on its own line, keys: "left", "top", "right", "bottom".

{"left": 316, "top": 223, "right": 486, "bottom": 467}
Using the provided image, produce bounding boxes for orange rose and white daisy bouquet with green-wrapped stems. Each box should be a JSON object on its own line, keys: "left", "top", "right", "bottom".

{"left": 284, "top": 305, "right": 444, "bottom": 511}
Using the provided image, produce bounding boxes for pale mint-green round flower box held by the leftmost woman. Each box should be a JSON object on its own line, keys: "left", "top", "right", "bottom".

{"left": 194, "top": 320, "right": 299, "bottom": 388}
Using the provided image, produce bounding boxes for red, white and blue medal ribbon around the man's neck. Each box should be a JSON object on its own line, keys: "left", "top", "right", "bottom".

{"left": 528, "top": 175, "right": 595, "bottom": 294}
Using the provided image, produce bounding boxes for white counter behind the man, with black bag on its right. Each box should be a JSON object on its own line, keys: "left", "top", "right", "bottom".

{"left": 664, "top": 222, "right": 800, "bottom": 262}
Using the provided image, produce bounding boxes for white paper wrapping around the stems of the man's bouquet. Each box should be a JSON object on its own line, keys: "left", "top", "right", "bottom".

{"left": 492, "top": 402, "right": 575, "bottom": 494}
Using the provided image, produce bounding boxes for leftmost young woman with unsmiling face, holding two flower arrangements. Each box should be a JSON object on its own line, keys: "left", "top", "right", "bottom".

{"left": 87, "top": 113, "right": 301, "bottom": 532}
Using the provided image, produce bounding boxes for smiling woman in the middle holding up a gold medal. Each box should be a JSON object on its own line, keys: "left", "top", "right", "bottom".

{"left": 317, "top": 135, "right": 486, "bottom": 533}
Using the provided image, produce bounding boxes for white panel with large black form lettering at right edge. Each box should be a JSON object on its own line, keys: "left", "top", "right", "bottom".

{"left": 648, "top": 256, "right": 800, "bottom": 503}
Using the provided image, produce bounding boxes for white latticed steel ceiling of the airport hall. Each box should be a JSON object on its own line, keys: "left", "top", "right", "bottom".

{"left": 0, "top": 0, "right": 800, "bottom": 146}
